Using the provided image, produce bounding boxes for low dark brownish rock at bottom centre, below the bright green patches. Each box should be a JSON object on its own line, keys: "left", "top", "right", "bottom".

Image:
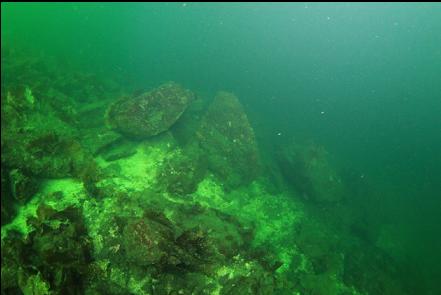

{"left": 122, "top": 209, "right": 215, "bottom": 272}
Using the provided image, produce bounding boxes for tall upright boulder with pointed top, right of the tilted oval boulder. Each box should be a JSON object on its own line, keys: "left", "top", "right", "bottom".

{"left": 197, "top": 92, "right": 260, "bottom": 188}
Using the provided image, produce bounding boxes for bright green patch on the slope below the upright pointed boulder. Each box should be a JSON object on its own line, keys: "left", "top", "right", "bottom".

{"left": 194, "top": 177, "right": 304, "bottom": 272}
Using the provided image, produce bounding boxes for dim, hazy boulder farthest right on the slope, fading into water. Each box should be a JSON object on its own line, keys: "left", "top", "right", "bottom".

{"left": 277, "top": 143, "right": 344, "bottom": 203}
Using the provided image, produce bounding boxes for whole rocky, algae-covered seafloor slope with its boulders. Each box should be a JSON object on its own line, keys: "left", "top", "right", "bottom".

{"left": 1, "top": 48, "right": 407, "bottom": 295}
